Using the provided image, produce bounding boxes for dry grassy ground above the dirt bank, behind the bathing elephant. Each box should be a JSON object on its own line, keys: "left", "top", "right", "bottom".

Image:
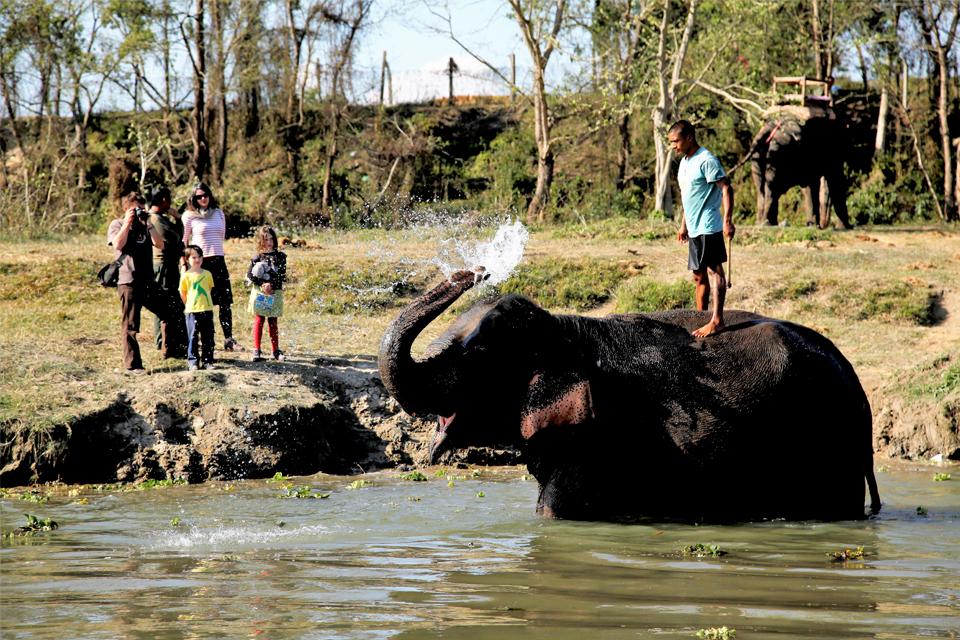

{"left": 0, "top": 221, "right": 960, "bottom": 436}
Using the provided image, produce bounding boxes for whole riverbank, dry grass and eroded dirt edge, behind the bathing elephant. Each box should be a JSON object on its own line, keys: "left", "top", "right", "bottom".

{"left": 0, "top": 220, "right": 960, "bottom": 487}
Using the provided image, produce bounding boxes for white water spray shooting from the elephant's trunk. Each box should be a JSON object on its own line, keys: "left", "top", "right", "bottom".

{"left": 433, "top": 220, "right": 530, "bottom": 285}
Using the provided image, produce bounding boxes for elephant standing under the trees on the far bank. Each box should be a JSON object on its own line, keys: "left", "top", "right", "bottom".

{"left": 748, "top": 106, "right": 851, "bottom": 229}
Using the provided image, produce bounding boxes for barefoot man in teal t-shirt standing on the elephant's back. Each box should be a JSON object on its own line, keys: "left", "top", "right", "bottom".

{"left": 667, "top": 120, "right": 736, "bottom": 338}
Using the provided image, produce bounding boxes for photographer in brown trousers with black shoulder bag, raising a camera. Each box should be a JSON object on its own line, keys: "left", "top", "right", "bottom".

{"left": 107, "top": 191, "right": 182, "bottom": 374}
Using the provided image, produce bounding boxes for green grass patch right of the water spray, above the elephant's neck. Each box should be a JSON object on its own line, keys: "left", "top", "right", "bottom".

{"left": 500, "top": 258, "right": 627, "bottom": 311}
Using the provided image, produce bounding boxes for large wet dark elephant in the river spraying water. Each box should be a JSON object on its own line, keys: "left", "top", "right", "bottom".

{"left": 379, "top": 268, "right": 880, "bottom": 521}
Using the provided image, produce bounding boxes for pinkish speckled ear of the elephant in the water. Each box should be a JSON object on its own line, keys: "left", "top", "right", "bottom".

{"left": 520, "top": 372, "right": 593, "bottom": 440}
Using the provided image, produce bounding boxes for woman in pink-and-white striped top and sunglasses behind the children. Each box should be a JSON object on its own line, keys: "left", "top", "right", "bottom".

{"left": 183, "top": 182, "right": 243, "bottom": 351}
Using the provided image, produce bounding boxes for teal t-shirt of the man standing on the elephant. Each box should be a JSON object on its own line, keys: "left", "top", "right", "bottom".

{"left": 677, "top": 147, "right": 727, "bottom": 238}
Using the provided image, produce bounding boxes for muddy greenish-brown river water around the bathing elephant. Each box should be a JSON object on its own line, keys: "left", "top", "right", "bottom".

{"left": 0, "top": 467, "right": 960, "bottom": 640}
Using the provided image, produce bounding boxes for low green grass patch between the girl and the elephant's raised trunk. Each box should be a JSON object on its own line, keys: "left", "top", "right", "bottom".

{"left": 287, "top": 262, "right": 436, "bottom": 315}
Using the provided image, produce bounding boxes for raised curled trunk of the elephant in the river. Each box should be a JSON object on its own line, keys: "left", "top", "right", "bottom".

{"left": 379, "top": 268, "right": 483, "bottom": 415}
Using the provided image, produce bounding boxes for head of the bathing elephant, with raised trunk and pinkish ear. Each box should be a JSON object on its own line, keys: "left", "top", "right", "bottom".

{"left": 379, "top": 267, "right": 591, "bottom": 463}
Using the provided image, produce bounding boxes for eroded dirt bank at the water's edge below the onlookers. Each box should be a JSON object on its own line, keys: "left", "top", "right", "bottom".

{"left": 0, "top": 356, "right": 518, "bottom": 487}
